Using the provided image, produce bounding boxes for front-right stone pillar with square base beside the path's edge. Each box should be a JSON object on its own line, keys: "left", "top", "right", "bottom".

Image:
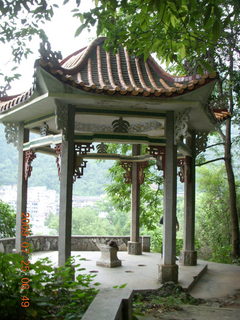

{"left": 160, "top": 111, "right": 178, "bottom": 283}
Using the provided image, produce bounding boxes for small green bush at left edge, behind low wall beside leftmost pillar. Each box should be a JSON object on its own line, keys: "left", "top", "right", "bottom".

{"left": 0, "top": 200, "right": 16, "bottom": 238}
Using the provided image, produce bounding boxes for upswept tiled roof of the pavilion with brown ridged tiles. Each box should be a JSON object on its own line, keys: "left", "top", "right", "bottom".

{"left": 0, "top": 37, "right": 229, "bottom": 119}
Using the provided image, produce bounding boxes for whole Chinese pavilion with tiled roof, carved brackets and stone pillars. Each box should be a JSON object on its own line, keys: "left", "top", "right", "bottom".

{"left": 0, "top": 37, "right": 227, "bottom": 282}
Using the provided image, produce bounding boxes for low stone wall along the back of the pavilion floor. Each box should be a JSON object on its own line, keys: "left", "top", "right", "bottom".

{"left": 0, "top": 236, "right": 150, "bottom": 253}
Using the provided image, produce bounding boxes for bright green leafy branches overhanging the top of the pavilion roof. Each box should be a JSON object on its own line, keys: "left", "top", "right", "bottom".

{"left": 74, "top": 0, "right": 240, "bottom": 66}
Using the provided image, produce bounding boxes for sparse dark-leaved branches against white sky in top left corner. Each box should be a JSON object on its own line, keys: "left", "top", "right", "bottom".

{"left": 0, "top": 0, "right": 57, "bottom": 96}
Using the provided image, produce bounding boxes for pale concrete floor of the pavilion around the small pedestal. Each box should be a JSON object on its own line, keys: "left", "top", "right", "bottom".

{"left": 31, "top": 251, "right": 206, "bottom": 290}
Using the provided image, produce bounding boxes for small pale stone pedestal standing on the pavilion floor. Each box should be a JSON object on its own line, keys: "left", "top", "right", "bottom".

{"left": 96, "top": 245, "right": 122, "bottom": 268}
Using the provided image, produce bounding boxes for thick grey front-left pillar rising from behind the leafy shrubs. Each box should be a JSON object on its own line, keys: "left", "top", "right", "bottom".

{"left": 58, "top": 106, "right": 75, "bottom": 266}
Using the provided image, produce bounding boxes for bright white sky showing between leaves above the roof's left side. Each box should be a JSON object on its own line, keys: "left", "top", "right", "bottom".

{"left": 0, "top": 0, "right": 96, "bottom": 95}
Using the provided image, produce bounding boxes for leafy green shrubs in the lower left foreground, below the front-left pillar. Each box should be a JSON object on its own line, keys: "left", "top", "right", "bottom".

{"left": 0, "top": 253, "right": 99, "bottom": 320}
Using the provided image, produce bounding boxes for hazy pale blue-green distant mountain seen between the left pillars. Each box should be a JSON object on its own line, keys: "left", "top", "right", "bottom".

{"left": 0, "top": 124, "right": 113, "bottom": 196}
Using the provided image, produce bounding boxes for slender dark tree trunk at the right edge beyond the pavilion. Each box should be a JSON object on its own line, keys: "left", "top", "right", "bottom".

{"left": 224, "top": 119, "right": 240, "bottom": 258}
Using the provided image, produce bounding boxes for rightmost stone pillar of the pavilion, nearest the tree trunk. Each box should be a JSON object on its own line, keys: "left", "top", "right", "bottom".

{"left": 180, "top": 134, "right": 197, "bottom": 266}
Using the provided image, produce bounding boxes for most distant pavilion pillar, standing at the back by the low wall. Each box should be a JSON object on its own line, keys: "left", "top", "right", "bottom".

{"left": 128, "top": 144, "right": 142, "bottom": 255}
